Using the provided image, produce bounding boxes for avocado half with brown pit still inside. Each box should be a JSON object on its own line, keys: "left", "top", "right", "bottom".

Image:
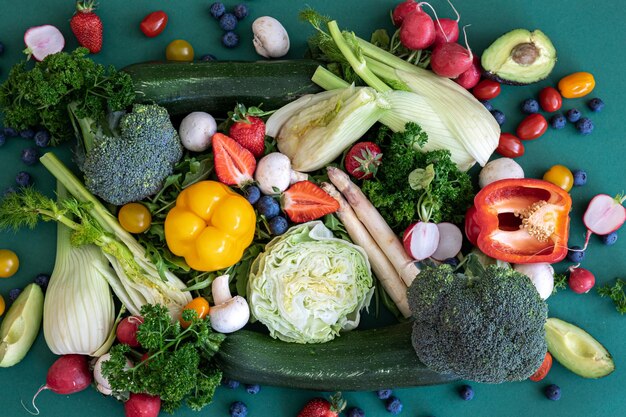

{"left": 481, "top": 29, "right": 556, "bottom": 85}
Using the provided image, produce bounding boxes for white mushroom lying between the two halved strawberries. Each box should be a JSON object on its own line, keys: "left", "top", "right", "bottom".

{"left": 254, "top": 152, "right": 308, "bottom": 195}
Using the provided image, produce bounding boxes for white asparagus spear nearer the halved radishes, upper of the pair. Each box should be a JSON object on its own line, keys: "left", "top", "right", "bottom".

{"left": 326, "top": 167, "right": 420, "bottom": 287}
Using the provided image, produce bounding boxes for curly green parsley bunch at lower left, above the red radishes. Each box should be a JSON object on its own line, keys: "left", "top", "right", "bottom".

{"left": 102, "top": 304, "right": 224, "bottom": 413}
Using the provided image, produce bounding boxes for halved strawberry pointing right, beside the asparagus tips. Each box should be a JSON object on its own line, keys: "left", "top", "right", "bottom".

{"left": 281, "top": 181, "right": 339, "bottom": 223}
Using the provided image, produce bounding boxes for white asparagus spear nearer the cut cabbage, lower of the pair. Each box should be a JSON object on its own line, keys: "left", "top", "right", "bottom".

{"left": 322, "top": 182, "right": 411, "bottom": 317}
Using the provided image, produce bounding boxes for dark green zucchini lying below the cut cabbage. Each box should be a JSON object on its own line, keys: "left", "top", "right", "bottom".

{"left": 216, "top": 323, "right": 458, "bottom": 391}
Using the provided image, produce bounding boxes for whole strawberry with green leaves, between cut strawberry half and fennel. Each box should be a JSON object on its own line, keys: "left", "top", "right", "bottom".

{"left": 228, "top": 104, "right": 268, "bottom": 158}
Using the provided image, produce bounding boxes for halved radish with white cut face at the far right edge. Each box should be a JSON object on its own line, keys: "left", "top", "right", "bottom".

{"left": 583, "top": 194, "right": 626, "bottom": 249}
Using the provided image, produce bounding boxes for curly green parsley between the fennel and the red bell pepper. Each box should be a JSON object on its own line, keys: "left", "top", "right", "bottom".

{"left": 362, "top": 123, "right": 474, "bottom": 233}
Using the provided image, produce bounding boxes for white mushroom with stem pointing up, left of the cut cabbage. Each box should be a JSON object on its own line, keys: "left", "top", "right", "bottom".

{"left": 209, "top": 275, "right": 250, "bottom": 333}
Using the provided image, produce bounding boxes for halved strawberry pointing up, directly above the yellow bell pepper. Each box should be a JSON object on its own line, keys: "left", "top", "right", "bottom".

{"left": 211, "top": 133, "right": 256, "bottom": 187}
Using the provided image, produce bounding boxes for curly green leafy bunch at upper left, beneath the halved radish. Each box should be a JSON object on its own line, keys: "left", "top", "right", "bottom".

{"left": 0, "top": 48, "right": 135, "bottom": 144}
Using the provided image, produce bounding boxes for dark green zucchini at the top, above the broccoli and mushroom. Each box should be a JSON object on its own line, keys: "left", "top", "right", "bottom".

{"left": 123, "top": 59, "right": 322, "bottom": 116}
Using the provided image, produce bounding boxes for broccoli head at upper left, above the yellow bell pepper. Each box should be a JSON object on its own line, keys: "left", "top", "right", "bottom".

{"left": 82, "top": 104, "right": 183, "bottom": 205}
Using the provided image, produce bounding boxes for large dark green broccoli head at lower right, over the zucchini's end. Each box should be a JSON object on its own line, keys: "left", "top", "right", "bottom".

{"left": 408, "top": 265, "right": 548, "bottom": 383}
